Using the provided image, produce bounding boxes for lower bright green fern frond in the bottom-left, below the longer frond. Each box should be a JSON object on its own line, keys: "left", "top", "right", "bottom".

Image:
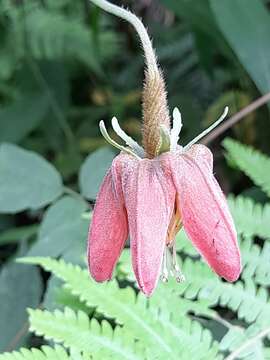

{"left": 28, "top": 308, "right": 140, "bottom": 360}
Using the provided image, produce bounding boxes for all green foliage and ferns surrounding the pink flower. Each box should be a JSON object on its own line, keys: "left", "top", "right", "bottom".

{"left": 0, "top": 0, "right": 270, "bottom": 360}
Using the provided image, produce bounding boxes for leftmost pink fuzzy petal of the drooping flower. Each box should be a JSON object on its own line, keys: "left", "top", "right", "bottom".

{"left": 88, "top": 158, "right": 128, "bottom": 282}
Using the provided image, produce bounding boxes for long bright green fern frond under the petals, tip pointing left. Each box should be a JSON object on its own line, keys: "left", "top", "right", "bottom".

{"left": 19, "top": 258, "right": 220, "bottom": 359}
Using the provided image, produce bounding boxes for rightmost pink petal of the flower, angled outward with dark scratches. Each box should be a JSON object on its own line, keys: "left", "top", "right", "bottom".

{"left": 171, "top": 148, "right": 241, "bottom": 281}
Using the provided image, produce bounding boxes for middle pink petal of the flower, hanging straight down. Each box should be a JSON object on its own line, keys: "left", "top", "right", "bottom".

{"left": 122, "top": 155, "right": 175, "bottom": 296}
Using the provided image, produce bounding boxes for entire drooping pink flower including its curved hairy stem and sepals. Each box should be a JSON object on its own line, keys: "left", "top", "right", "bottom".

{"left": 88, "top": 0, "right": 241, "bottom": 296}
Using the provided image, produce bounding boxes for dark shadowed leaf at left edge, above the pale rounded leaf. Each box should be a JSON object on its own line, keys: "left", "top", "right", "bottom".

{"left": 0, "top": 94, "right": 49, "bottom": 142}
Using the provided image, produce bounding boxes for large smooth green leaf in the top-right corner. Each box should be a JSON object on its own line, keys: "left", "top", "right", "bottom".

{"left": 210, "top": 0, "right": 270, "bottom": 93}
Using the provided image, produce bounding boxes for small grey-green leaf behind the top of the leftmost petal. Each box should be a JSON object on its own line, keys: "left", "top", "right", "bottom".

{"left": 79, "top": 147, "right": 115, "bottom": 199}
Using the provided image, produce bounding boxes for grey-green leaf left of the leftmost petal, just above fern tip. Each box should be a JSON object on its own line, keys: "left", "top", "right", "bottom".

{"left": 28, "top": 196, "right": 88, "bottom": 257}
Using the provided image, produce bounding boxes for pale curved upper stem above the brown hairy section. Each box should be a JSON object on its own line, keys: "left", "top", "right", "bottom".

{"left": 90, "top": 0, "right": 159, "bottom": 74}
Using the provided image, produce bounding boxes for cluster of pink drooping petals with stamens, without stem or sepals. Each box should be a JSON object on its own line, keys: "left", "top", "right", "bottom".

{"left": 88, "top": 119, "right": 241, "bottom": 296}
